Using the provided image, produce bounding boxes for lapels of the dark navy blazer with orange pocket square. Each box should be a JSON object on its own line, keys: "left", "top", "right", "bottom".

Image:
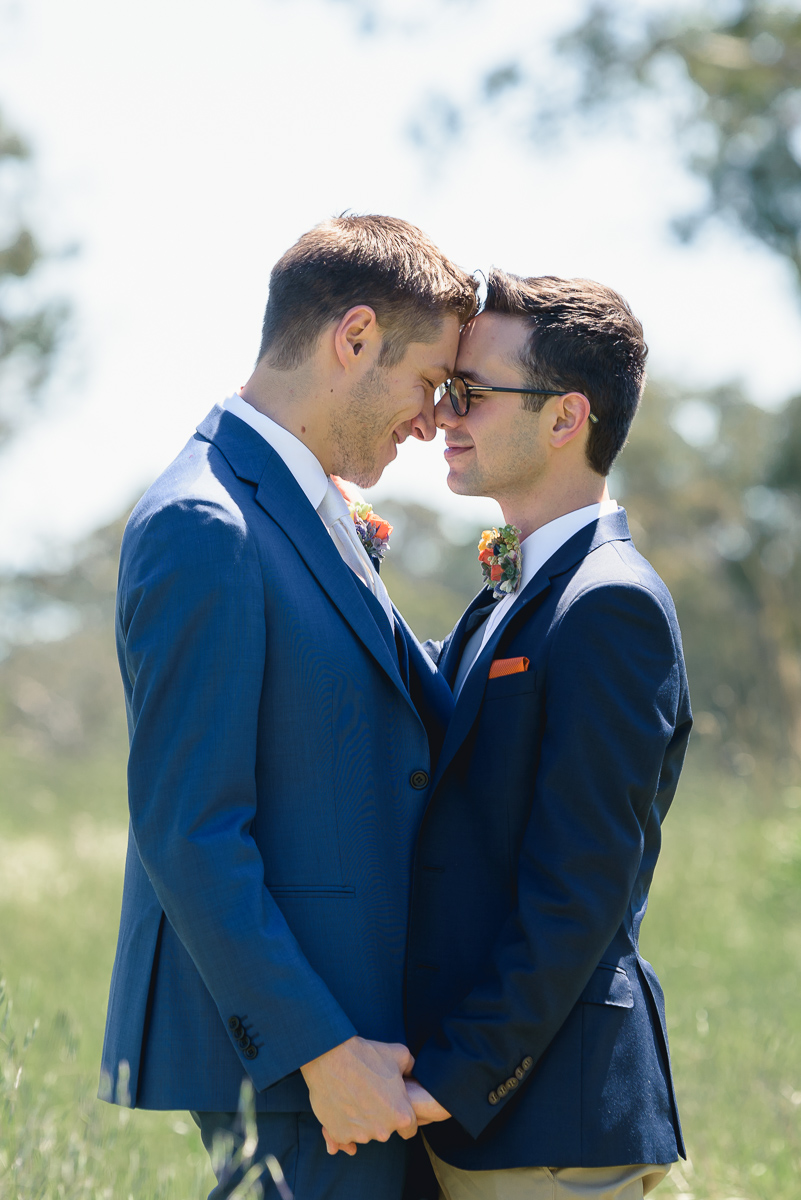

{"left": 434, "top": 509, "right": 631, "bottom": 784}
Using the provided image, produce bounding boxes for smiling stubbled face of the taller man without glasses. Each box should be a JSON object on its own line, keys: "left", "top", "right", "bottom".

{"left": 330, "top": 314, "right": 459, "bottom": 487}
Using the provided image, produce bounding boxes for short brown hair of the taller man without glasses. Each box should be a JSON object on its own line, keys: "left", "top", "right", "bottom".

{"left": 259, "top": 215, "right": 476, "bottom": 371}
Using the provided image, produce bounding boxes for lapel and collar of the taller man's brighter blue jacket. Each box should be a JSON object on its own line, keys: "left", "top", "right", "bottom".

{"left": 198, "top": 407, "right": 414, "bottom": 708}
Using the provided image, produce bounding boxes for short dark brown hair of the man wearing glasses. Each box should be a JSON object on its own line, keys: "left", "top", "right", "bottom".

{"left": 484, "top": 268, "right": 648, "bottom": 475}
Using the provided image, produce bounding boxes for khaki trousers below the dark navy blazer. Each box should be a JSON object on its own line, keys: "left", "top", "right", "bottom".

{"left": 426, "top": 1144, "right": 670, "bottom": 1200}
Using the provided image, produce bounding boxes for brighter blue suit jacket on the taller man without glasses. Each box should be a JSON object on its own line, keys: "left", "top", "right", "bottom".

{"left": 101, "top": 408, "right": 452, "bottom": 1111}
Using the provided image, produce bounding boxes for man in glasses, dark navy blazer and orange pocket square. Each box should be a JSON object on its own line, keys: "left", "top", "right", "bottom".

{"left": 402, "top": 271, "right": 692, "bottom": 1200}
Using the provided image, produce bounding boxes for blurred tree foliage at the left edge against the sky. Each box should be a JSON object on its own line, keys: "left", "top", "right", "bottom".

{"left": 0, "top": 103, "right": 67, "bottom": 446}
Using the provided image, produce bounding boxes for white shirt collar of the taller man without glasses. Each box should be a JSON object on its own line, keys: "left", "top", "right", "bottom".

{"left": 223, "top": 392, "right": 395, "bottom": 628}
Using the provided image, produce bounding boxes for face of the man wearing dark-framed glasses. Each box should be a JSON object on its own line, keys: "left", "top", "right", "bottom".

{"left": 435, "top": 312, "right": 550, "bottom": 502}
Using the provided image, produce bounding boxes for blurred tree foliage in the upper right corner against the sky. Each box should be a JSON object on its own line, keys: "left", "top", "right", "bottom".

{"left": 474, "top": 0, "right": 801, "bottom": 287}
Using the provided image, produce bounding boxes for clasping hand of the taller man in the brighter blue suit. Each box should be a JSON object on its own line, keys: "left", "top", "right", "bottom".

{"left": 301, "top": 1038, "right": 417, "bottom": 1153}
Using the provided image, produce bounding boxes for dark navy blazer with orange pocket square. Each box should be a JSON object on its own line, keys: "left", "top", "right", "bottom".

{"left": 406, "top": 511, "right": 692, "bottom": 1170}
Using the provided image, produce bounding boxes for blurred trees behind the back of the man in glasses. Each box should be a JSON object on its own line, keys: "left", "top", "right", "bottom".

{"left": 610, "top": 383, "right": 801, "bottom": 784}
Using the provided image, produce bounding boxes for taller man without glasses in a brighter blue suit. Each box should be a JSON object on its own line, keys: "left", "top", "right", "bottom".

{"left": 102, "top": 217, "right": 475, "bottom": 1200}
